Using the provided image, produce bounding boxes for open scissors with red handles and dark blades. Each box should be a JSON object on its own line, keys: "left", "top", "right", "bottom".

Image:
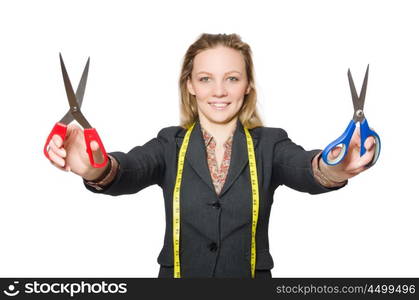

{"left": 44, "top": 53, "right": 108, "bottom": 168}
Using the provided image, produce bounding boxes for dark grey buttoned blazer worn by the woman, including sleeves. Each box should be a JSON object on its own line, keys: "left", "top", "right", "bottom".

{"left": 85, "top": 121, "right": 344, "bottom": 278}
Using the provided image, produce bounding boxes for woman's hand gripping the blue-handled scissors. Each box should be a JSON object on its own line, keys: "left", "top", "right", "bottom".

{"left": 319, "top": 127, "right": 376, "bottom": 182}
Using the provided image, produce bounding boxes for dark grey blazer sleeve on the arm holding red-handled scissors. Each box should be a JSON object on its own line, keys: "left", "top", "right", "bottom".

{"left": 84, "top": 128, "right": 171, "bottom": 196}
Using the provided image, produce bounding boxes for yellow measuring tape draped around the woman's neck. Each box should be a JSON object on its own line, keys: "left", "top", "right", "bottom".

{"left": 173, "top": 122, "right": 259, "bottom": 278}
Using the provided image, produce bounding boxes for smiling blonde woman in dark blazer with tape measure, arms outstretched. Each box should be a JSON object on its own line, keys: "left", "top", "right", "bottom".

{"left": 49, "top": 34, "right": 374, "bottom": 278}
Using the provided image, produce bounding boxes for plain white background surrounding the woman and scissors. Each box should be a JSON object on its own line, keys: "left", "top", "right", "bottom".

{"left": 0, "top": 0, "right": 419, "bottom": 277}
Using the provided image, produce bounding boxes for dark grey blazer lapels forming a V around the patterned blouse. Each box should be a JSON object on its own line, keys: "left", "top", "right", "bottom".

{"left": 176, "top": 119, "right": 258, "bottom": 198}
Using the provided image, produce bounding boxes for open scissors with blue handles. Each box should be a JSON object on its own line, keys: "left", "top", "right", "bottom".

{"left": 322, "top": 65, "right": 381, "bottom": 166}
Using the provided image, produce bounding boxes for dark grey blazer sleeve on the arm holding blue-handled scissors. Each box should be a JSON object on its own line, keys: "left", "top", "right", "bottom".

{"left": 272, "top": 129, "right": 343, "bottom": 194}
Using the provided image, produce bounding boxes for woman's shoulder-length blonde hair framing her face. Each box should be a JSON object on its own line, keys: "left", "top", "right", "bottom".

{"left": 179, "top": 33, "right": 263, "bottom": 129}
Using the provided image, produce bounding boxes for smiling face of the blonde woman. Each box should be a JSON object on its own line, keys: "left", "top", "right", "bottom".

{"left": 187, "top": 46, "right": 250, "bottom": 124}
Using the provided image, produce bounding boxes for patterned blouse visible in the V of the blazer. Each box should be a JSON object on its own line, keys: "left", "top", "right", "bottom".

{"left": 201, "top": 126, "right": 233, "bottom": 195}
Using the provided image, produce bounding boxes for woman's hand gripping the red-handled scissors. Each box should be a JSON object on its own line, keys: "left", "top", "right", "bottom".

{"left": 48, "top": 124, "right": 109, "bottom": 180}
